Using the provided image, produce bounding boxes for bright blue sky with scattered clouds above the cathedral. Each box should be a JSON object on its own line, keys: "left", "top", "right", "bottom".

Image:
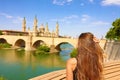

{"left": 0, "top": 0, "right": 120, "bottom": 38}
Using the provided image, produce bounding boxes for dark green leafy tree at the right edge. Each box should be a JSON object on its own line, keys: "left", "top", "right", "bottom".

{"left": 105, "top": 18, "right": 120, "bottom": 40}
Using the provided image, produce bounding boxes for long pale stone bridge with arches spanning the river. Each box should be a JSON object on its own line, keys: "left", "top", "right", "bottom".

{"left": 0, "top": 35, "right": 77, "bottom": 50}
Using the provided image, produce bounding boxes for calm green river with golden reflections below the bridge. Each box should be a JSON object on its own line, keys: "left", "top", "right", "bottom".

{"left": 0, "top": 44, "right": 71, "bottom": 80}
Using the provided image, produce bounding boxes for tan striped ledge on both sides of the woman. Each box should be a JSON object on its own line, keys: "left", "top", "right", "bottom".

{"left": 29, "top": 61, "right": 120, "bottom": 80}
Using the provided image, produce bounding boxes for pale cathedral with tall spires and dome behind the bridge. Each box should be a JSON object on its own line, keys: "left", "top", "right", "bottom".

{"left": 22, "top": 17, "right": 59, "bottom": 37}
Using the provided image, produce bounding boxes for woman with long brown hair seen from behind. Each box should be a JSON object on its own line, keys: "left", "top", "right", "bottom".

{"left": 66, "top": 32, "right": 103, "bottom": 80}
